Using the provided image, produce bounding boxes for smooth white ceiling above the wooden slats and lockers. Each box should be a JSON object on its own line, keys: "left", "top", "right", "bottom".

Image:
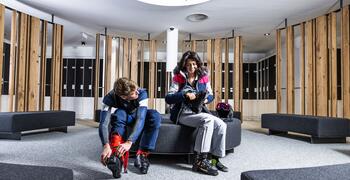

{"left": 3, "top": 0, "right": 350, "bottom": 53}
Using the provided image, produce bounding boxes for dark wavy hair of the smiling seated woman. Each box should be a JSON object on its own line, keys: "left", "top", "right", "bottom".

{"left": 174, "top": 51, "right": 207, "bottom": 77}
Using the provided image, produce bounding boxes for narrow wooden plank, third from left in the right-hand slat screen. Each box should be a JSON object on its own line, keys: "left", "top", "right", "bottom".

{"left": 300, "top": 23, "right": 305, "bottom": 114}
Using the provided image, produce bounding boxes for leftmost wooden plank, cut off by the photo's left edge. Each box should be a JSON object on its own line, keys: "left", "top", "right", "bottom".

{"left": 0, "top": 4, "right": 5, "bottom": 111}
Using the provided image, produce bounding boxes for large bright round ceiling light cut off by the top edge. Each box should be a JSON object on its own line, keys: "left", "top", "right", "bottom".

{"left": 138, "top": 0, "right": 210, "bottom": 6}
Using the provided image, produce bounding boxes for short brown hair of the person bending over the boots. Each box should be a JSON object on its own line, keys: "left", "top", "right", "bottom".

{"left": 113, "top": 77, "right": 138, "bottom": 96}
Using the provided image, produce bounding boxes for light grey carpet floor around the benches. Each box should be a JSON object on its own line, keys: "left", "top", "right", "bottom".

{"left": 0, "top": 123, "right": 350, "bottom": 180}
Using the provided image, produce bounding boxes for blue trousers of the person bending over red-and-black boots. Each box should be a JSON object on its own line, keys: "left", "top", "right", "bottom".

{"left": 111, "top": 109, "right": 161, "bottom": 150}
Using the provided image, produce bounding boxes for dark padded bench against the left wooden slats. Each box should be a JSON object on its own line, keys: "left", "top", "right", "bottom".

{"left": 0, "top": 111, "right": 75, "bottom": 140}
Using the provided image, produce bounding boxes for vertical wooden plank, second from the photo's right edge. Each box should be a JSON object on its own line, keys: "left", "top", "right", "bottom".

{"left": 329, "top": 12, "right": 338, "bottom": 117}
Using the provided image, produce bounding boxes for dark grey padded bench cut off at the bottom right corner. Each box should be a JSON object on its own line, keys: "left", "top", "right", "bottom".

{"left": 241, "top": 163, "right": 350, "bottom": 180}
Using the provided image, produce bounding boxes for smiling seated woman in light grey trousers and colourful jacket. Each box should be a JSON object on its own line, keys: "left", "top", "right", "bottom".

{"left": 165, "top": 51, "right": 228, "bottom": 176}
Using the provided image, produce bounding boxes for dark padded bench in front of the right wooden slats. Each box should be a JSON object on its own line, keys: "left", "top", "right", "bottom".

{"left": 261, "top": 113, "right": 350, "bottom": 143}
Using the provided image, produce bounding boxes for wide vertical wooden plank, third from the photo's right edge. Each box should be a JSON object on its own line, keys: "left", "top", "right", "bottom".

{"left": 316, "top": 16, "right": 328, "bottom": 116}
